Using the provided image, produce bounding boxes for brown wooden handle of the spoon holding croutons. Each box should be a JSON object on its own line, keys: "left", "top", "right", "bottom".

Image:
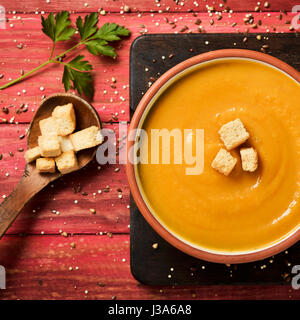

{"left": 0, "top": 170, "right": 50, "bottom": 239}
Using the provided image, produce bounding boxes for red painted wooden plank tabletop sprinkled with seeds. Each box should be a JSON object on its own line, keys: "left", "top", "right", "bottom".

{"left": 0, "top": 0, "right": 300, "bottom": 299}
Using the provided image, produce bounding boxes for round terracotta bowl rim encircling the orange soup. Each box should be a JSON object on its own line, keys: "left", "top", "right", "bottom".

{"left": 126, "top": 49, "right": 300, "bottom": 264}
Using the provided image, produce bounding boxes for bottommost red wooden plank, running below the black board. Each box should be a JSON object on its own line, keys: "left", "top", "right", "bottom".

{"left": 0, "top": 235, "right": 300, "bottom": 300}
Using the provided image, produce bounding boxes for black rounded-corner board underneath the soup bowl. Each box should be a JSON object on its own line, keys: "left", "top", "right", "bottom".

{"left": 130, "top": 33, "right": 300, "bottom": 285}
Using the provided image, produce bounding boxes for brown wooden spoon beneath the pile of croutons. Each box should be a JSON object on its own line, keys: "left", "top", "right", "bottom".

{"left": 0, "top": 93, "right": 101, "bottom": 239}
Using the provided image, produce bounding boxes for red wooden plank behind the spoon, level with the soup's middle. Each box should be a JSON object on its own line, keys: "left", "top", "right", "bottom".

{"left": 0, "top": 124, "right": 129, "bottom": 234}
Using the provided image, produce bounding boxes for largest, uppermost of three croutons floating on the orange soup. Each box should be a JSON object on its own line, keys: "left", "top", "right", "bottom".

{"left": 219, "top": 119, "right": 249, "bottom": 150}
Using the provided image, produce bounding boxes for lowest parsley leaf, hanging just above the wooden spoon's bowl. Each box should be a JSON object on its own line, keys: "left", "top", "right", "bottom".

{"left": 62, "top": 55, "right": 94, "bottom": 98}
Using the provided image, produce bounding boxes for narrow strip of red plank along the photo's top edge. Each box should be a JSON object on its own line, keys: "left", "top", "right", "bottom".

{"left": 2, "top": 0, "right": 298, "bottom": 13}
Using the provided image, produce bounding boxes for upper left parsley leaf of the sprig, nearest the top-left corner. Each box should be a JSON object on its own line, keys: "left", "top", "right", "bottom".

{"left": 42, "top": 11, "right": 76, "bottom": 43}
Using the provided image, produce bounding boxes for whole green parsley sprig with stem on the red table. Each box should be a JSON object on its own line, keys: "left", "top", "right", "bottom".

{"left": 0, "top": 11, "right": 130, "bottom": 98}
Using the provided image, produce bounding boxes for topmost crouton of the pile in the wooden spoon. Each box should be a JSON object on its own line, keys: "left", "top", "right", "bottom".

{"left": 52, "top": 103, "right": 76, "bottom": 136}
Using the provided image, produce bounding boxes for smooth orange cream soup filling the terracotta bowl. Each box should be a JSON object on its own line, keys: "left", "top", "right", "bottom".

{"left": 136, "top": 59, "right": 300, "bottom": 253}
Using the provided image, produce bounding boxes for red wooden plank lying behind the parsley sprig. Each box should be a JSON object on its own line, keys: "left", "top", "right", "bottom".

{"left": 0, "top": 13, "right": 293, "bottom": 123}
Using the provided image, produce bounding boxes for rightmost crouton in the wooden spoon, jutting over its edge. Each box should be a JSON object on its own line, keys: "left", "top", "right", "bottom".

{"left": 70, "top": 126, "right": 103, "bottom": 151}
